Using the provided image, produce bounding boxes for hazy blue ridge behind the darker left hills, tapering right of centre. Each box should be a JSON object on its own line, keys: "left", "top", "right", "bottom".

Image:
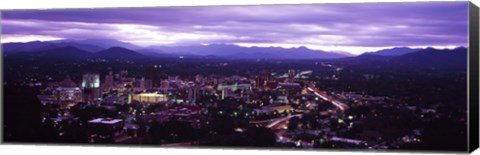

{"left": 2, "top": 39, "right": 351, "bottom": 59}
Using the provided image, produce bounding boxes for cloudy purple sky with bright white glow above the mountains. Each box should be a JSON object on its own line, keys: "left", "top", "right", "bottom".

{"left": 1, "top": 2, "right": 468, "bottom": 54}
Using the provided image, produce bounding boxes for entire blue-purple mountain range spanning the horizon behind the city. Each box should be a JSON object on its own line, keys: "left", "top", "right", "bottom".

{"left": 2, "top": 39, "right": 467, "bottom": 65}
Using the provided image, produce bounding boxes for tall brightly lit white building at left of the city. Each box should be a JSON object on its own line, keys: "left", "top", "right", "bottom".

{"left": 82, "top": 73, "right": 101, "bottom": 102}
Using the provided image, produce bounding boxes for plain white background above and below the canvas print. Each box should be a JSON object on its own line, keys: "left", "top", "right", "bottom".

{"left": 0, "top": 0, "right": 480, "bottom": 155}
